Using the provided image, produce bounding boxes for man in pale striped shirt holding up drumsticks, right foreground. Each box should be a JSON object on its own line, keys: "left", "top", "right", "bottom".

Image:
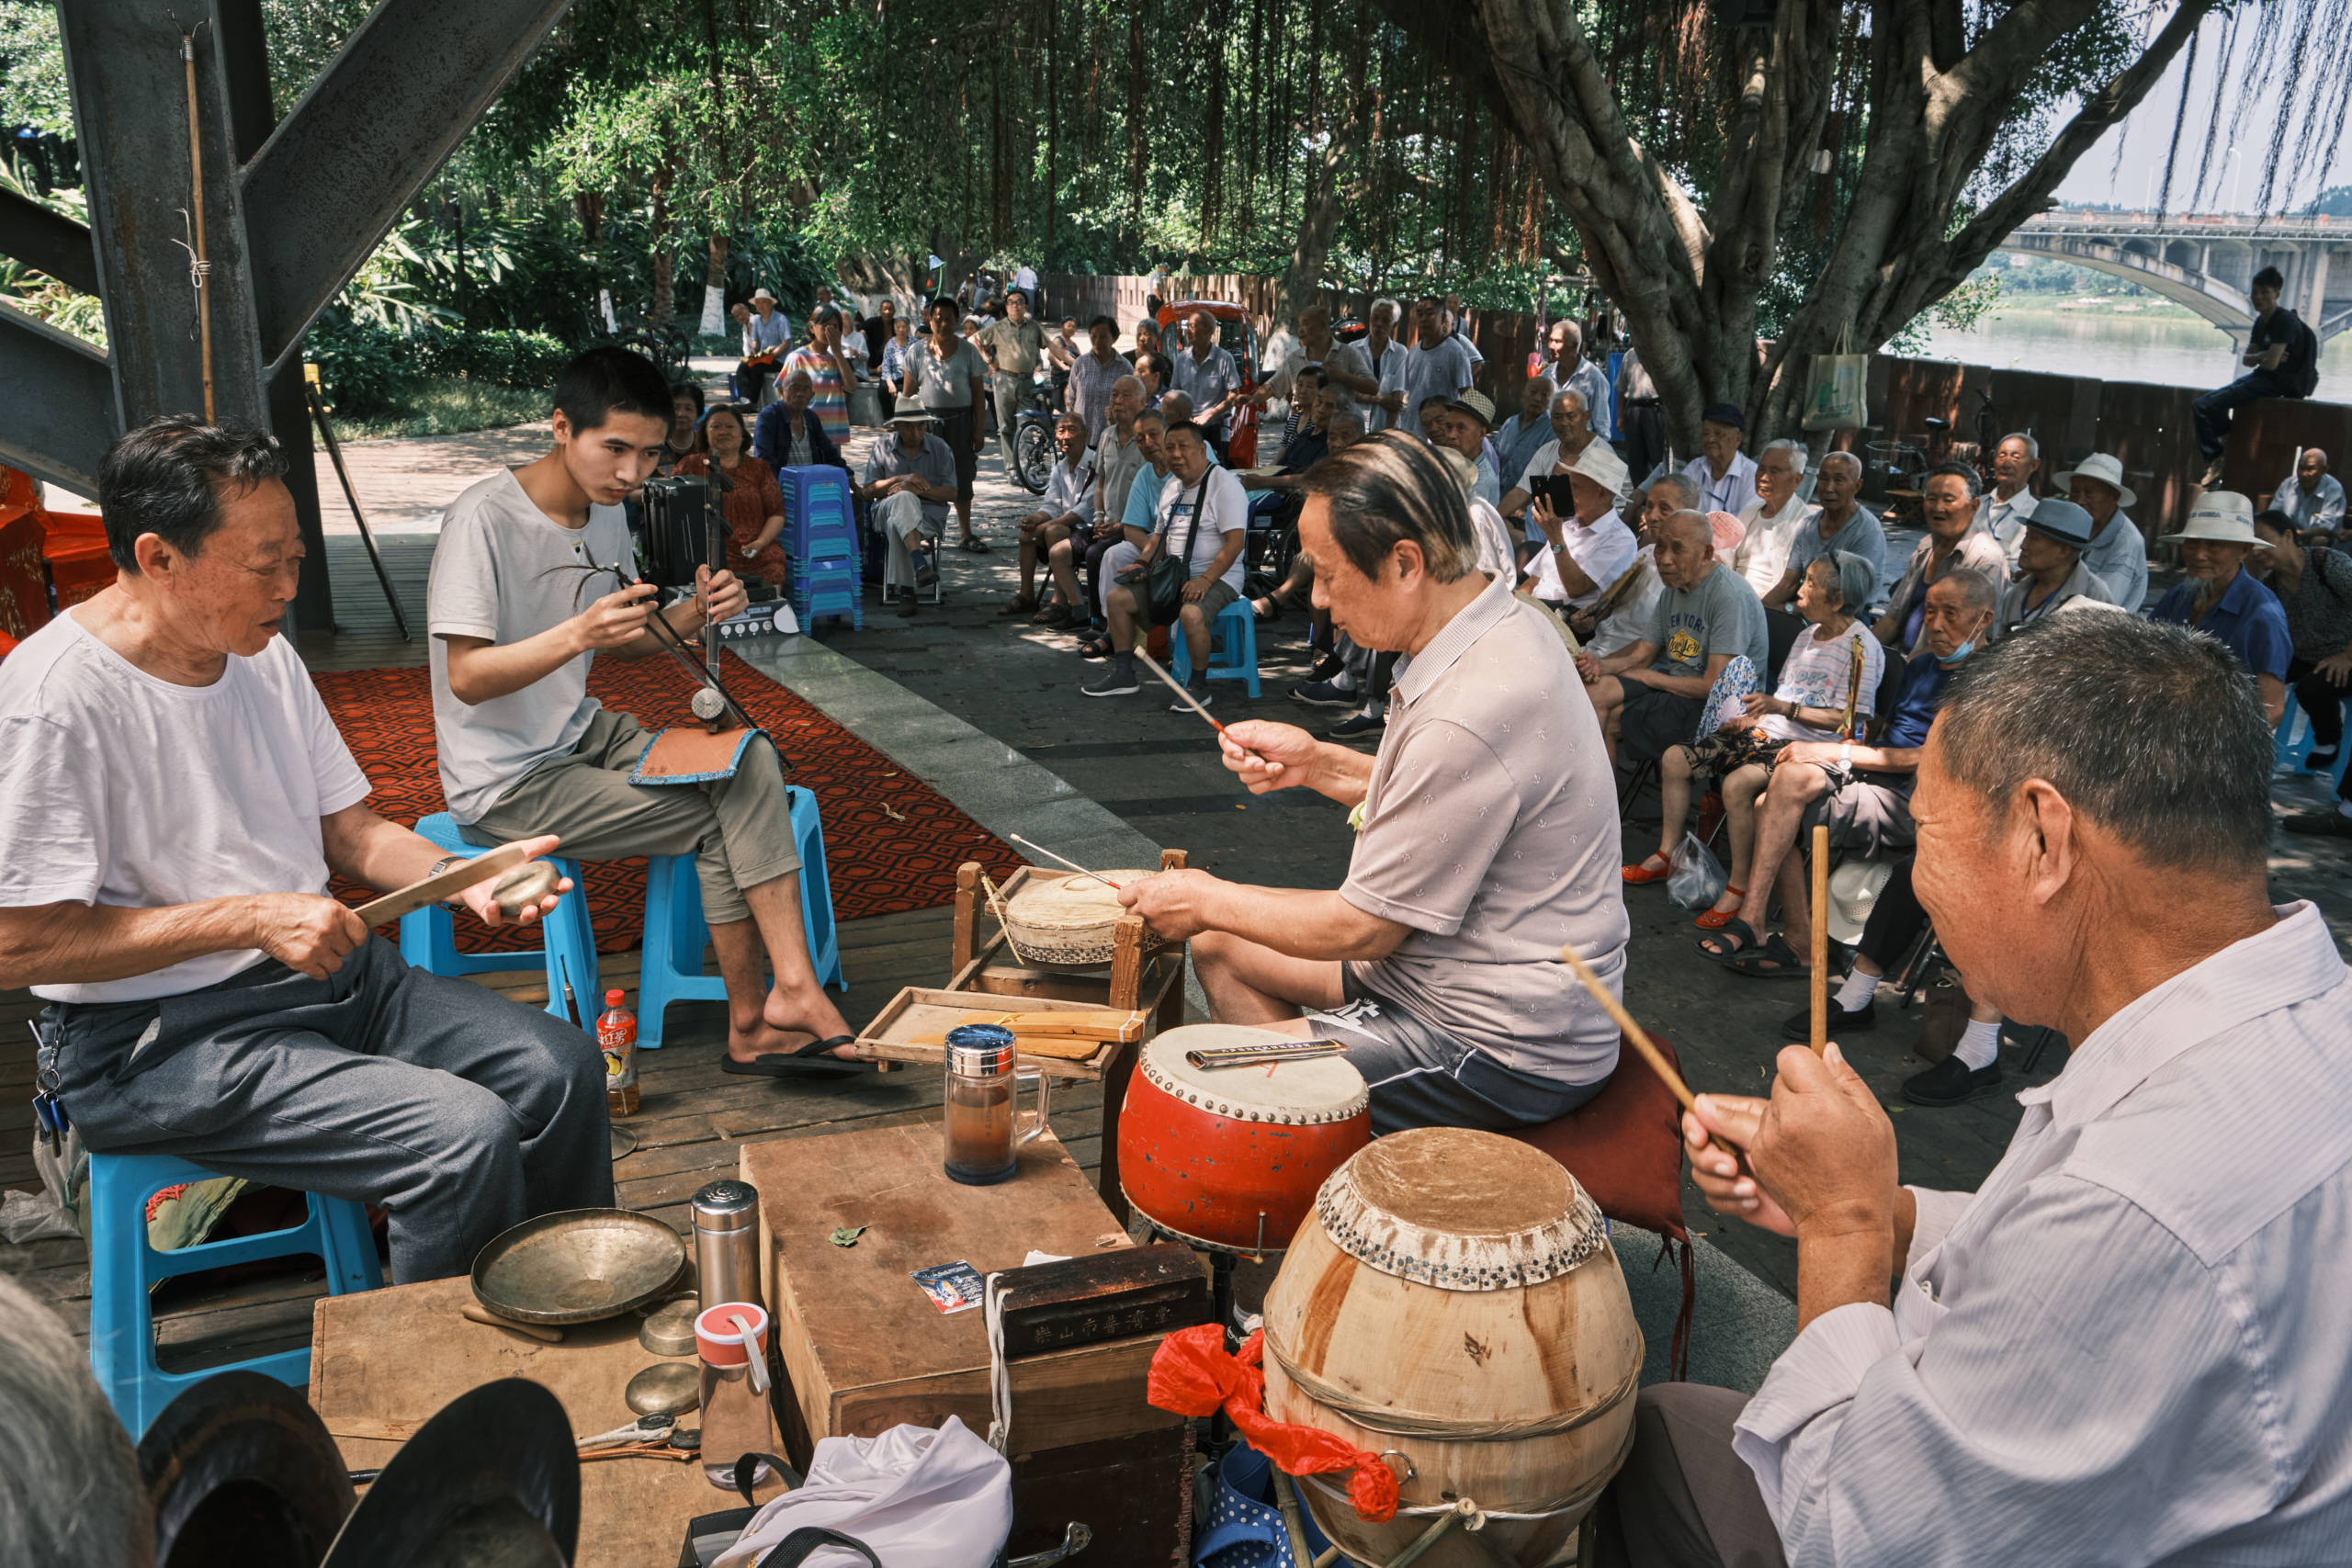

{"left": 1600, "top": 611, "right": 2352, "bottom": 1568}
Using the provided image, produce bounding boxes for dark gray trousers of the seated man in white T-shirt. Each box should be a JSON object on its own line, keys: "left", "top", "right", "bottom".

{"left": 50, "top": 936, "right": 612, "bottom": 1283}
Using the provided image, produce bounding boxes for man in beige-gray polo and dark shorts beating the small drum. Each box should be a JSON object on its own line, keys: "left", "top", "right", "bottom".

{"left": 1120, "top": 433, "right": 1628, "bottom": 1134}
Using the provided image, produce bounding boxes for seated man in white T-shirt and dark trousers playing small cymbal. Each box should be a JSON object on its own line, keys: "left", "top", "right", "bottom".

{"left": 0, "top": 413, "right": 606, "bottom": 1283}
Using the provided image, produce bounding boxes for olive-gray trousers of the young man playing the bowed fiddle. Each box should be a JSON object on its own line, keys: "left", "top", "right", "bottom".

{"left": 458, "top": 707, "right": 799, "bottom": 926}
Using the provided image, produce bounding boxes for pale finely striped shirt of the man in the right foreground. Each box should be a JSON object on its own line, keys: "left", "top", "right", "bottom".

{"left": 1734, "top": 903, "right": 2352, "bottom": 1568}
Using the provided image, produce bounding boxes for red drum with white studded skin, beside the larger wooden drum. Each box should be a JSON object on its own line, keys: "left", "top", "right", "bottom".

{"left": 1120, "top": 1022, "right": 1371, "bottom": 1256}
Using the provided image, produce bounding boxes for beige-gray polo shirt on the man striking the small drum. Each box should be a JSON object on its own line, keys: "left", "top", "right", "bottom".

{"left": 1339, "top": 579, "right": 1630, "bottom": 1084}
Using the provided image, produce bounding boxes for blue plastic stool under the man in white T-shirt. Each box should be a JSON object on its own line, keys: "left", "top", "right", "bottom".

{"left": 89, "top": 1155, "right": 383, "bottom": 1441}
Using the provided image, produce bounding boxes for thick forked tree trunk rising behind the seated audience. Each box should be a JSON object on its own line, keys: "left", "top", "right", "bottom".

{"left": 1378, "top": 0, "right": 2216, "bottom": 451}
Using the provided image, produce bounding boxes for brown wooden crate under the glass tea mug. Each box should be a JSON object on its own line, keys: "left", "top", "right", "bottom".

{"left": 741, "top": 1112, "right": 1183, "bottom": 1460}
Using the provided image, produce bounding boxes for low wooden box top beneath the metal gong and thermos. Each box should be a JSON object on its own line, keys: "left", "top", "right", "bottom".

{"left": 311, "top": 1279, "right": 790, "bottom": 1568}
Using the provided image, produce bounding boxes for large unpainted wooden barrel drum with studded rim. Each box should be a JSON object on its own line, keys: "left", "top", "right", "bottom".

{"left": 1265, "top": 1128, "right": 1642, "bottom": 1568}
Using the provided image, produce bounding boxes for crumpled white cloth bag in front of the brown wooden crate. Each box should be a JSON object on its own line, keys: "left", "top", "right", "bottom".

{"left": 713, "top": 1416, "right": 1013, "bottom": 1568}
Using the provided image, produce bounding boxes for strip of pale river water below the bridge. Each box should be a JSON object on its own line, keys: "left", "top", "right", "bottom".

{"left": 1928, "top": 308, "right": 2352, "bottom": 402}
